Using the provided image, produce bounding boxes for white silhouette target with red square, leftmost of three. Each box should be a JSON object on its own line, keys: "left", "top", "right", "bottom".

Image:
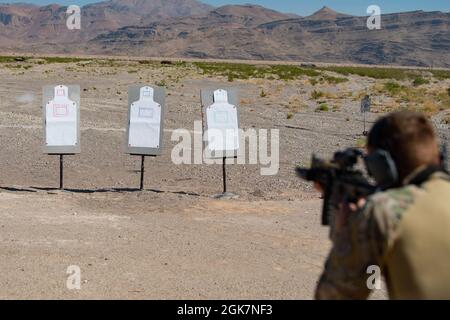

{"left": 45, "top": 85, "right": 78, "bottom": 147}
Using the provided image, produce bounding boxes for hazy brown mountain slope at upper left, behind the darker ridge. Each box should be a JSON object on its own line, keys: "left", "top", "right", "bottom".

{"left": 0, "top": 0, "right": 212, "bottom": 45}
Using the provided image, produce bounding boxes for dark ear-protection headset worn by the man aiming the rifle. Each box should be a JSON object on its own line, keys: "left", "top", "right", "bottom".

{"left": 364, "top": 143, "right": 448, "bottom": 190}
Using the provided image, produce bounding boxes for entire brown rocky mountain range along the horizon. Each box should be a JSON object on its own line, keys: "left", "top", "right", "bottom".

{"left": 0, "top": 0, "right": 450, "bottom": 67}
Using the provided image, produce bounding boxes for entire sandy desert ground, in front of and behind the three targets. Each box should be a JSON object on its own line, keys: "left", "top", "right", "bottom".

{"left": 0, "top": 58, "right": 448, "bottom": 299}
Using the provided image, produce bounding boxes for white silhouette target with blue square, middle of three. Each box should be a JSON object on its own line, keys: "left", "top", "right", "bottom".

{"left": 128, "top": 87, "right": 161, "bottom": 149}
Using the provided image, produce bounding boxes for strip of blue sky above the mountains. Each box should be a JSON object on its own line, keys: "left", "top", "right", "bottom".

{"left": 0, "top": 0, "right": 450, "bottom": 16}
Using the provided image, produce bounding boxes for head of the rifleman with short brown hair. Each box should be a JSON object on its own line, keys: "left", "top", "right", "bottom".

{"left": 367, "top": 111, "right": 440, "bottom": 181}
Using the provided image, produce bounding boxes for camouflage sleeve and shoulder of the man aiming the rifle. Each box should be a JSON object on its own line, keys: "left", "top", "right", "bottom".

{"left": 316, "top": 186, "right": 420, "bottom": 299}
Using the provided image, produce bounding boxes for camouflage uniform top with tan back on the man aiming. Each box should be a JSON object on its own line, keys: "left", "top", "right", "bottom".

{"left": 316, "top": 172, "right": 450, "bottom": 299}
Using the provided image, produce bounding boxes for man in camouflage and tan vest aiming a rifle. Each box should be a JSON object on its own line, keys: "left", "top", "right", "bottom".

{"left": 315, "top": 111, "right": 450, "bottom": 299}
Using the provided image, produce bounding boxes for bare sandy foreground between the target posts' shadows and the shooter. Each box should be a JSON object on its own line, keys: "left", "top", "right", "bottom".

{"left": 0, "top": 189, "right": 385, "bottom": 299}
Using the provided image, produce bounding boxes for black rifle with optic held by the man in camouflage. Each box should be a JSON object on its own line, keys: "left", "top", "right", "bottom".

{"left": 296, "top": 148, "right": 377, "bottom": 226}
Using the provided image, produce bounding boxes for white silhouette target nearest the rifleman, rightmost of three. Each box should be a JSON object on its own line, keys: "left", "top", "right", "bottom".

{"left": 206, "top": 89, "right": 239, "bottom": 153}
